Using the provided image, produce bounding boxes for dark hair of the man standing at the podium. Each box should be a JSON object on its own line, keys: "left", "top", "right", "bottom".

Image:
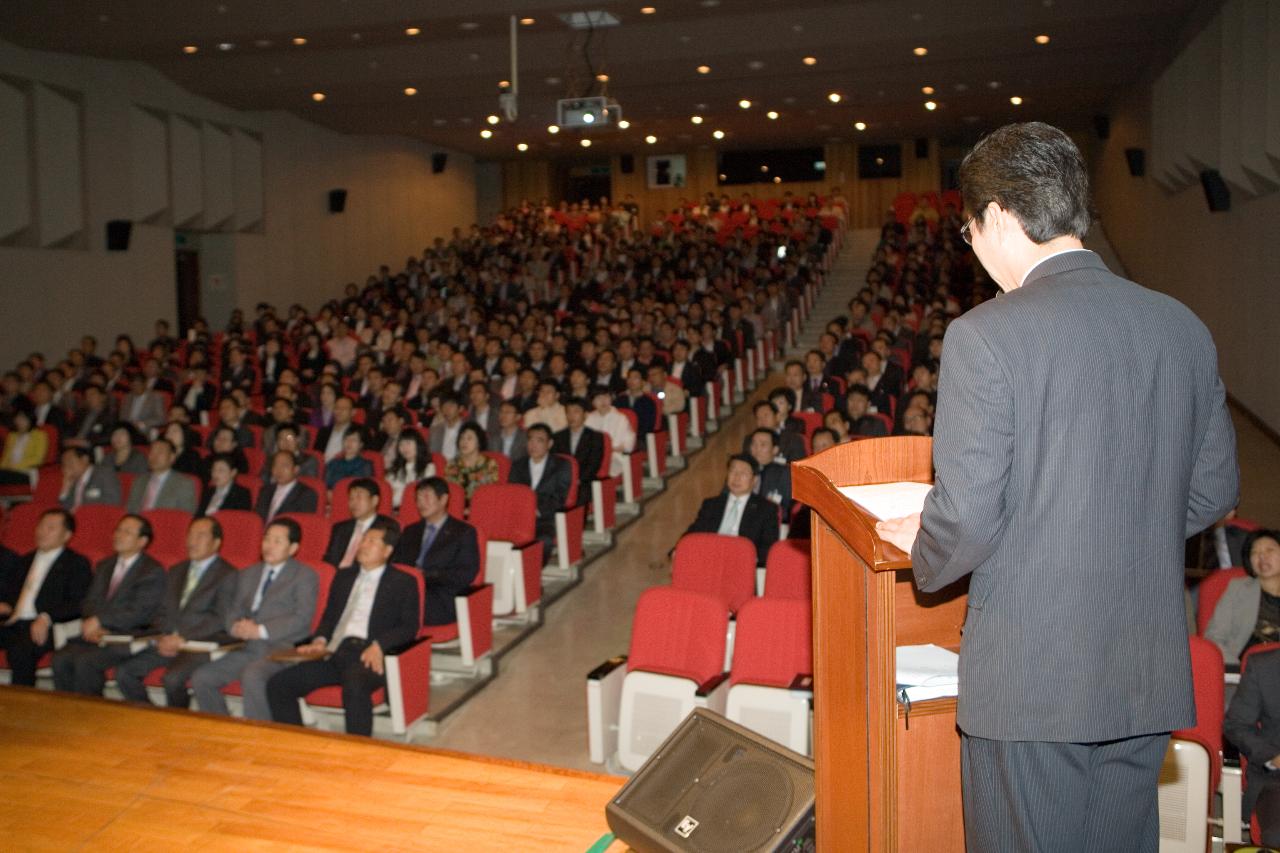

{"left": 960, "top": 122, "right": 1093, "bottom": 243}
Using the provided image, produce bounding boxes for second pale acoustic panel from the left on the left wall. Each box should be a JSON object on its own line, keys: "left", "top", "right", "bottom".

{"left": 32, "top": 83, "right": 84, "bottom": 246}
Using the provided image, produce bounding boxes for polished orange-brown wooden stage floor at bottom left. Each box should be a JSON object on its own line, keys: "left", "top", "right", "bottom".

{"left": 0, "top": 686, "right": 626, "bottom": 853}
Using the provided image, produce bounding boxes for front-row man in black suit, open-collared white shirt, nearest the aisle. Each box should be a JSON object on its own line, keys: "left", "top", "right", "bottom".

{"left": 266, "top": 519, "right": 421, "bottom": 736}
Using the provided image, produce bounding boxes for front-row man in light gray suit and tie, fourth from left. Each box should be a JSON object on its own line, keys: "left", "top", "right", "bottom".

{"left": 191, "top": 519, "right": 320, "bottom": 720}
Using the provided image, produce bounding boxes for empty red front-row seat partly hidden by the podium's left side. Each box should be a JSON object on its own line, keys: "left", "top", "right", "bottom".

{"left": 724, "top": 598, "right": 813, "bottom": 754}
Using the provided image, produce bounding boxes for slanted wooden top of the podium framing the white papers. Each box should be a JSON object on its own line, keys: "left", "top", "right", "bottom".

{"left": 791, "top": 435, "right": 933, "bottom": 571}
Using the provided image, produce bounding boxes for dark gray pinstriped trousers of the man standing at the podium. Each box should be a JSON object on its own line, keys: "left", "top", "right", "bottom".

{"left": 960, "top": 733, "right": 1169, "bottom": 853}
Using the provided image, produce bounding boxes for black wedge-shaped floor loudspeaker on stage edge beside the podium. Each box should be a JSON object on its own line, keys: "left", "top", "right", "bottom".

{"left": 605, "top": 708, "right": 817, "bottom": 853}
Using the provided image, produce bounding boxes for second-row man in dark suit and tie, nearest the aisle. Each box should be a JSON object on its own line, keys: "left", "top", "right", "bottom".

{"left": 392, "top": 476, "right": 480, "bottom": 625}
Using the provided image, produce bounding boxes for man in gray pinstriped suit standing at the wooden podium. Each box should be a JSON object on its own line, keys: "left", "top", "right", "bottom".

{"left": 882, "top": 123, "right": 1239, "bottom": 852}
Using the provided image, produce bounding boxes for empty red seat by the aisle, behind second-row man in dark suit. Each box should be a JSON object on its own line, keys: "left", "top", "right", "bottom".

{"left": 476, "top": 483, "right": 543, "bottom": 616}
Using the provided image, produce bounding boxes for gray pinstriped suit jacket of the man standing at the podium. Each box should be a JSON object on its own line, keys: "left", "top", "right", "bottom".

{"left": 911, "top": 251, "right": 1239, "bottom": 743}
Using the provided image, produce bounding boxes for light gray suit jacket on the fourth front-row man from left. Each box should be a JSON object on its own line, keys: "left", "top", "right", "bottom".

{"left": 227, "top": 560, "right": 320, "bottom": 648}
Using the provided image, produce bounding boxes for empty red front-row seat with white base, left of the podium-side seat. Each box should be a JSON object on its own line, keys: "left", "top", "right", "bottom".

{"left": 586, "top": 587, "right": 728, "bottom": 771}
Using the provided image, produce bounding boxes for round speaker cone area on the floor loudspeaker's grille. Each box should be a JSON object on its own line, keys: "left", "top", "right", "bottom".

{"left": 672, "top": 760, "right": 795, "bottom": 853}
